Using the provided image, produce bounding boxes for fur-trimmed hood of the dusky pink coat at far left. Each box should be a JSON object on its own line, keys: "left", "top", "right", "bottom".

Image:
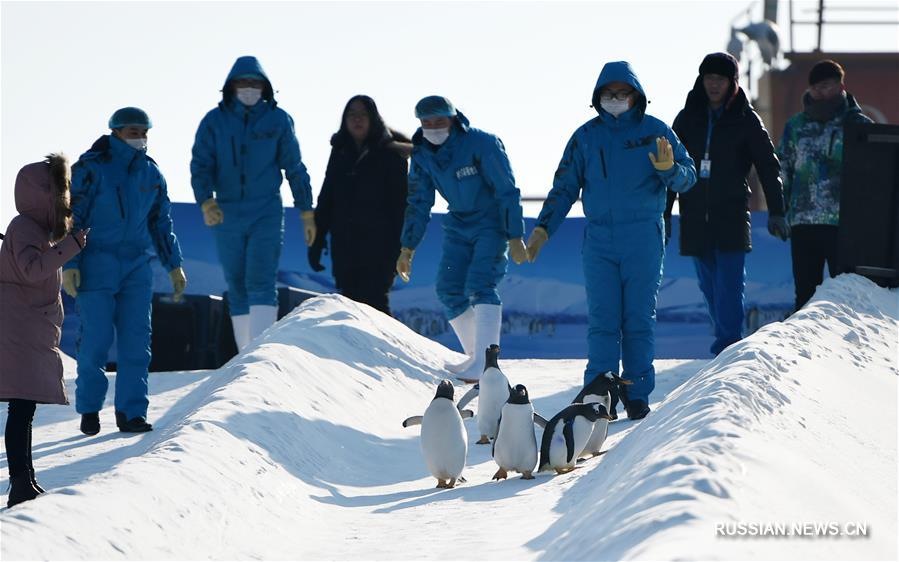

{"left": 15, "top": 154, "right": 72, "bottom": 242}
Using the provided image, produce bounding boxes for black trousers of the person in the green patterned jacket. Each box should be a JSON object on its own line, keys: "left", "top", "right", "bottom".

{"left": 790, "top": 224, "right": 839, "bottom": 310}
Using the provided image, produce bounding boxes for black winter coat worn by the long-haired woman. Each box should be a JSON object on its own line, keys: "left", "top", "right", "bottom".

{"left": 315, "top": 134, "right": 408, "bottom": 285}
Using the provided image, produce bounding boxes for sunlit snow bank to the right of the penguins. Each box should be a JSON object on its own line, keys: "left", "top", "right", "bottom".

{"left": 532, "top": 275, "right": 899, "bottom": 560}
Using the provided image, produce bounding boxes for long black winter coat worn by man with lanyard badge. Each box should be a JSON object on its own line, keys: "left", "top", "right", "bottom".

{"left": 665, "top": 82, "right": 784, "bottom": 256}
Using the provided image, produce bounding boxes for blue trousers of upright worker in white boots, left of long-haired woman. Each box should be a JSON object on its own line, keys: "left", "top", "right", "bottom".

{"left": 212, "top": 198, "right": 284, "bottom": 316}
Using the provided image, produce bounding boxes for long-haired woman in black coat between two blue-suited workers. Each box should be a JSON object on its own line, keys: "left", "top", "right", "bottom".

{"left": 309, "top": 95, "right": 412, "bottom": 314}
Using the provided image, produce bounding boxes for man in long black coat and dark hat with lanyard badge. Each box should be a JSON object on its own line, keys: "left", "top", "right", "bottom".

{"left": 665, "top": 53, "right": 789, "bottom": 355}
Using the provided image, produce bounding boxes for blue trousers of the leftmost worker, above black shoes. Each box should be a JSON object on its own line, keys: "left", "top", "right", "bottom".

{"left": 75, "top": 249, "right": 153, "bottom": 419}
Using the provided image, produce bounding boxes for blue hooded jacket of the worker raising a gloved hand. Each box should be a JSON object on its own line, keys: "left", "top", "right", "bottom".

{"left": 537, "top": 61, "right": 696, "bottom": 235}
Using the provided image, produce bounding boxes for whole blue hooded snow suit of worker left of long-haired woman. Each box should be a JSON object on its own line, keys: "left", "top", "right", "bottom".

{"left": 190, "top": 57, "right": 312, "bottom": 316}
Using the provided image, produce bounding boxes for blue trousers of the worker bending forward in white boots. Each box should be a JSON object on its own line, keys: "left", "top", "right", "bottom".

{"left": 436, "top": 223, "right": 509, "bottom": 319}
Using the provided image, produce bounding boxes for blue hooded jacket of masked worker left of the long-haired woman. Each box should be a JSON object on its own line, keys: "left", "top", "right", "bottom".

{"left": 190, "top": 56, "right": 312, "bottom": 211}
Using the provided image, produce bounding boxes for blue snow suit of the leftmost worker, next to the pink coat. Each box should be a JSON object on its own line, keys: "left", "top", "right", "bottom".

{"left": 65, "top": 135, "right": 181, "bottom": 420}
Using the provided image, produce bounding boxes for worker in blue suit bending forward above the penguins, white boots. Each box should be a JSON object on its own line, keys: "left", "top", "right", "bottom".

{"left": 396, "top": 96, "right": 527, "bottom": 382}
